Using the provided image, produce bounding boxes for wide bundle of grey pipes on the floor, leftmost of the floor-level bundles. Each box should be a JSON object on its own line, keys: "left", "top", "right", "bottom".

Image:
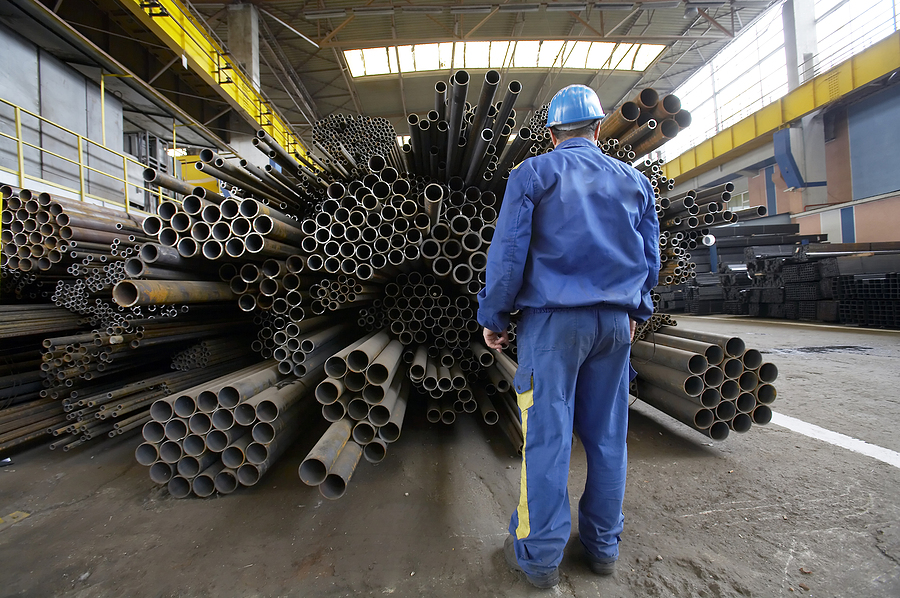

{"left": 135, "top": 360, "right": 324, "bottom": 498}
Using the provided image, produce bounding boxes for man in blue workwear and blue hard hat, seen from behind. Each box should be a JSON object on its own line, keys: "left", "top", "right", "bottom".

{"left": 478, "top": 85, "right": 659, "bottom": 588}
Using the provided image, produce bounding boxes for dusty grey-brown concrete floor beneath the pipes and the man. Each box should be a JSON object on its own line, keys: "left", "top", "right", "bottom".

{"left": 0, "top": 317, "right": 900, "bottom": 598}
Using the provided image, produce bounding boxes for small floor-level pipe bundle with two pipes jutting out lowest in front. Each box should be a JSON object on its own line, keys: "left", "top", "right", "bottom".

{"left": 299, "top": 330, "right": 412, "bottom": 500}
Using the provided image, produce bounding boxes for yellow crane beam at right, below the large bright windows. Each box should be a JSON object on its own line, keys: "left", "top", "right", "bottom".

{"left": 663, "top": 32, "right": 900, "bottom": 184}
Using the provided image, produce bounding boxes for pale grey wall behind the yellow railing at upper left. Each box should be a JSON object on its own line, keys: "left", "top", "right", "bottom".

{"left": 0, "top": 25, "right": 123, "bottom": 201}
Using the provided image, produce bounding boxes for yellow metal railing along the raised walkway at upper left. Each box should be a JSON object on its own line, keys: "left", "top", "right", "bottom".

{"left": 0, "top": 98, "right": 162, "bottom": 218}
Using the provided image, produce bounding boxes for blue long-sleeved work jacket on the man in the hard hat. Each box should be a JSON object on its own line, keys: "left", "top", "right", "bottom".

{"left": 478, "top": 137, "right": 659, "bottom": 332}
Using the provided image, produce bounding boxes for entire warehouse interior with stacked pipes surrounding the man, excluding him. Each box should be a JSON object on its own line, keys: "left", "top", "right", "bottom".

{"left": 0, "top": 0, "right": 900, "bottom": 598}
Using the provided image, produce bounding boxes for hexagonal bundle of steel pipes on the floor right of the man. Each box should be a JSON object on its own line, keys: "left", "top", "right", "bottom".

{"left": 631, "top": 326, "right": 778, "bottom": 440}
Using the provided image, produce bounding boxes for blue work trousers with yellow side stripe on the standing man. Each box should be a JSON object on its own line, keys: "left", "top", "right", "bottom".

{"left": 509, "top": 306, "right": 630, "bottom": 575}
